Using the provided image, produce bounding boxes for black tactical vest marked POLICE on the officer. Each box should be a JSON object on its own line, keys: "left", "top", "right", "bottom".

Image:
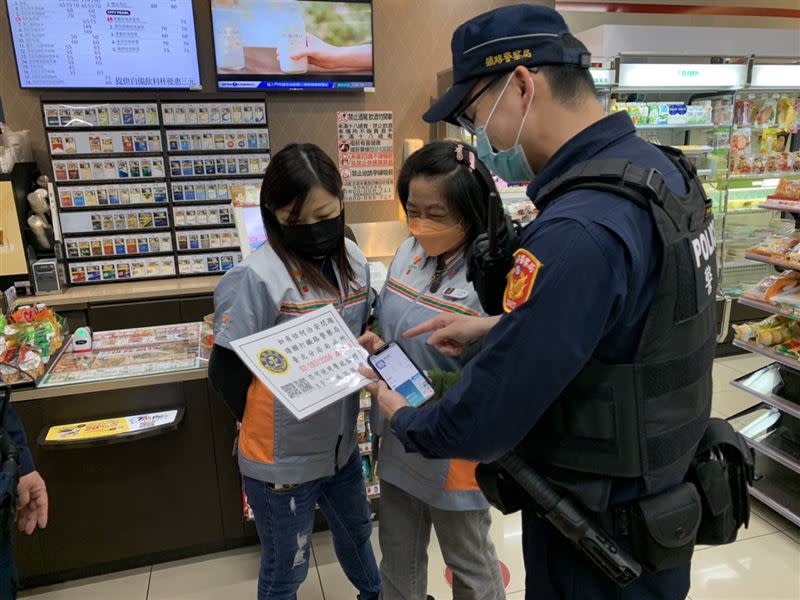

{"left": 517, "top": 147, "right": 717, "bottom": 511}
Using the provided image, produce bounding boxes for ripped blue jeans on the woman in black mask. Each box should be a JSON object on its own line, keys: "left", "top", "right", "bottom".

{"left": 244, "top": 451, "right": 381, "bottom": 600}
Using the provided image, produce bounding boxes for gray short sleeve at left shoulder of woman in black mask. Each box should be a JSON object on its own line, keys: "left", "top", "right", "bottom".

{"left": 214, "top": 266, "right": 278, "bottom": 350}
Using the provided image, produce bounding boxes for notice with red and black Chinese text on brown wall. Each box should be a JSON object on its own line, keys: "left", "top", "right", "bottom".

{"left": 336, "top": 111, "right": 394, "bottom": 202}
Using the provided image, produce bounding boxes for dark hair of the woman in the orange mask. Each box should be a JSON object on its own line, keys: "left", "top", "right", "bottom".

{"left": 397, "top": 140, "right": 503, "bottom": 247}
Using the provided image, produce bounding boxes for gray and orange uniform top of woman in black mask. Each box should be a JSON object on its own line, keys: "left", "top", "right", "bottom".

{"left": 214, "top": 240, "right": 370, "bottom": 484}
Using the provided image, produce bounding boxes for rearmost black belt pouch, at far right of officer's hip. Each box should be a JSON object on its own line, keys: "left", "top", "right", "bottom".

{"left": 687, "top": 419, "right": 755, "bottom": 546}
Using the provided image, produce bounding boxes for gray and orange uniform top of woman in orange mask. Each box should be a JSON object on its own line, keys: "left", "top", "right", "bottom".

{"left": 373, "top": 237, "right": 489, "bottom": 511}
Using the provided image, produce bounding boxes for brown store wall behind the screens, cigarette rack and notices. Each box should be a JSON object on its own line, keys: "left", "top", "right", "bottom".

{"left": 0, "top": 0, "right": 554, "bottom": 223}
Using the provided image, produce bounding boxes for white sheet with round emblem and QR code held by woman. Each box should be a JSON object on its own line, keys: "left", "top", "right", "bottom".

{"left": 232, "top": 305, "right": 370, "bottom": 420}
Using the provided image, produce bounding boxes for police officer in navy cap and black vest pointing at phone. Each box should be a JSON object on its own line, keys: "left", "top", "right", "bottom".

{"left": 362, "top": 5, "right": 715, "bottom": 600}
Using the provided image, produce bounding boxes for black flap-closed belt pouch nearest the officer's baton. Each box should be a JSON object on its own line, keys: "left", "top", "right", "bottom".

{"left": 629, "top": 483, "right": 702, "bottom": 572}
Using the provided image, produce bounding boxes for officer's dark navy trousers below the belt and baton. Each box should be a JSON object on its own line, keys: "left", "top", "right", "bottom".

{"left": 522, "top": 510, "right": 691, "bottom": 600}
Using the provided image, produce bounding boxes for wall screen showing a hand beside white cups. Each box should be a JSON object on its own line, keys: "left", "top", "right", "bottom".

{"left": 211, "top": 0, "right": 375, "bottom": 91}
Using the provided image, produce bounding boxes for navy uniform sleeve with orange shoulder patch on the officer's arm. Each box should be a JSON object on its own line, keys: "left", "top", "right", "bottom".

{"left": 392, "top": 219, "right": 629, "bottom": 462}
